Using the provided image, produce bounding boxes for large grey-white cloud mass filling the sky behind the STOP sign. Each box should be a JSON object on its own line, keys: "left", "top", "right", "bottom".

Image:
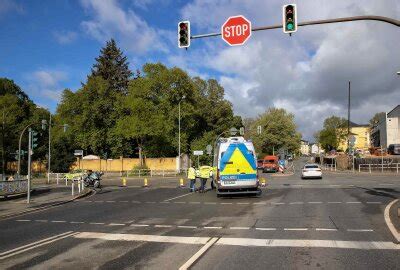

{"left": 180, "top": 0, "right": 400, "bottom": 140}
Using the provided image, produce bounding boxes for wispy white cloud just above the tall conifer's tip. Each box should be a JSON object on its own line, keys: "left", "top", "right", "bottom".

{"left": 81, "top": 0, "right": 167, "bottom": 54}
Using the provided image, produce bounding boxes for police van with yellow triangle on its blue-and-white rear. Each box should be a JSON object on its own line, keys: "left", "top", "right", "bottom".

{"left": 213, "top": 137, "right": 261, "bottom": 197}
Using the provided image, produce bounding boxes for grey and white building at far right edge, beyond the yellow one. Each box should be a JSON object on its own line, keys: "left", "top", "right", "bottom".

{"left": 371, "top": 105, "right": 400, "bottom": 149}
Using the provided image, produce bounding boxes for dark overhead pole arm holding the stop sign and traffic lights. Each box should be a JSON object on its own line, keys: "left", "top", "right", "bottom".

{"left": 190, "top": 15, "right": 400, "bottom": 39}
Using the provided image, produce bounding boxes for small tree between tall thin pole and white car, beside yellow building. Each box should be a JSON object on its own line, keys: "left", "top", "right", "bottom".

{"left": 315, "top": 116, "right": 347, "bottom": 151}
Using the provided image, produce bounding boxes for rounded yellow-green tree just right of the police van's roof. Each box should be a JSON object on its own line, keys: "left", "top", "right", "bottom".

{"left": 250, "top": 108, "right": 301, "bottom": 157}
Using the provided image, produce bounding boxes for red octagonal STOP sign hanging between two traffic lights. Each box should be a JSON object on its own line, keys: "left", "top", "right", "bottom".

{"left": 221, "top": 15, "right": 251, "bottom": 46}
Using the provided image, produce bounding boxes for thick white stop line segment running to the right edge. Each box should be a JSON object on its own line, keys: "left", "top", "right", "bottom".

{"left": 216, "top": 237, "right": 400, "bottom": 250}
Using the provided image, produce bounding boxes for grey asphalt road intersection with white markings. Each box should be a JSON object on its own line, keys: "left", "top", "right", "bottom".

{"left": 0, "top": 159, "right": 400, "bottom": 269}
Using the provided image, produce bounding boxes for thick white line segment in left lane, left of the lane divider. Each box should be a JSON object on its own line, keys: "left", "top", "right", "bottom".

{"left": 74, "top": 232, "right": 210, "bottom": 245}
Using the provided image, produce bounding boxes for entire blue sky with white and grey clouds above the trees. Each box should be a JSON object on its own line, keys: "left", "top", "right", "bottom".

{"left": 0, "top": 0, "right": 400, "bottom": 141}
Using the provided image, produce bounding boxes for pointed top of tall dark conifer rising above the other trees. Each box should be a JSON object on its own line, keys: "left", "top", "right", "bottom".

{"left": 91, "top": 39, "right": 132, "bottom": 94}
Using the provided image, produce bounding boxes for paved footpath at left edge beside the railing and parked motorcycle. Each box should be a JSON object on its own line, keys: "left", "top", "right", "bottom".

{"left": 0, "top": 183, "right": 92, "bottom": 219}
